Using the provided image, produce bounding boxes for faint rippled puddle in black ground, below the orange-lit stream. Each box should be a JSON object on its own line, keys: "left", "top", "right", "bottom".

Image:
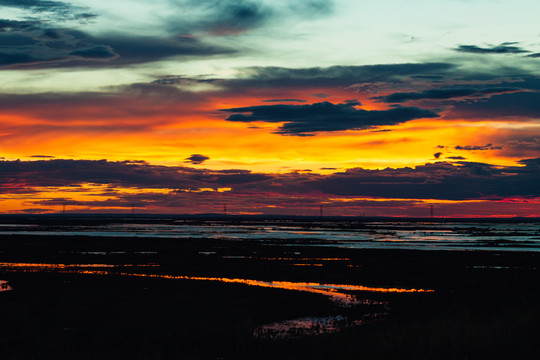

{"left": 253, "top": 312, "right": 387, "bottom": 339}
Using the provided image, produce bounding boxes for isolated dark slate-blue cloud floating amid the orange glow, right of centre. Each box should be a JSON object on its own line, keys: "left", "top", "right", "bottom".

{"left": 221, "top": 101, "right": 439, "bottom": 135}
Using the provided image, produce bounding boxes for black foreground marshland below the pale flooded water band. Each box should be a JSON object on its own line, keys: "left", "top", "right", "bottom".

{"left": 0, "top": 218, "right": 540, "bottom": 360}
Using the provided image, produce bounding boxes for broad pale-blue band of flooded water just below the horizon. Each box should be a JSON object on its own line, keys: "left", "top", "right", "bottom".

{"left": 0, "top": 221, "right": 540, "bottom": 250}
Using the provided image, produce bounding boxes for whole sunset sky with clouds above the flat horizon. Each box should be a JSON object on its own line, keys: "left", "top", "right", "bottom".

{"left": 0, "top": 0, "right": 540, "bottom": 217}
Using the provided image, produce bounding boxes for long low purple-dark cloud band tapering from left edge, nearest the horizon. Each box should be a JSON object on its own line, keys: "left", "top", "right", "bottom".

{"left": 0, "top": 159, "right": 270, "bottom": 191}
